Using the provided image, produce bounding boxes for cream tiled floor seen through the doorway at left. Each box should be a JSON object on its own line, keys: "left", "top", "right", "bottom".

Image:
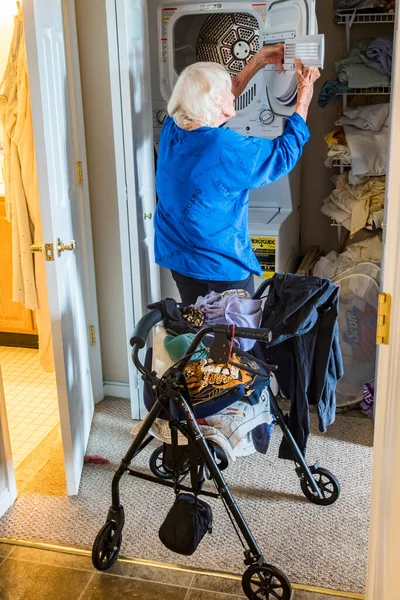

{"left": 0, "top": 346, "right": 59, "bottom": 468}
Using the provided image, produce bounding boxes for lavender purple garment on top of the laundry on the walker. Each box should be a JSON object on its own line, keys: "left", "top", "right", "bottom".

{"left": 194, "top": 292, "right": 262, "bottom": 351}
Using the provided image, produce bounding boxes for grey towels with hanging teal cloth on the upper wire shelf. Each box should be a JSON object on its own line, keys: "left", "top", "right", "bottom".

{"left": 318, "top": 36, "right": 393, "bottom": 108}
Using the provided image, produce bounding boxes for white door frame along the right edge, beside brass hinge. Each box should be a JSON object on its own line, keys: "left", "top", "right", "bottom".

{"left": 366, "top": 6, "right": 400, "bottom": 600}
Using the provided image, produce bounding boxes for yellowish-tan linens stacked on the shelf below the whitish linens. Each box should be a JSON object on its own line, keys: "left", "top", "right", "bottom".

{"left": 321, "top": 173, "right": 385, "bottom": 236}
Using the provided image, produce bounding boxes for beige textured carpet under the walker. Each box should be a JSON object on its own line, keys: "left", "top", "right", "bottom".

{"left": 0, "top": 399, "right": 373, "bottom": 592}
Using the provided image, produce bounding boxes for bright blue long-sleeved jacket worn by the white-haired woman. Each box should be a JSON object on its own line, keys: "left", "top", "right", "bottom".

{"left": 154, "top": 113, "right": 310, "bottom": 281}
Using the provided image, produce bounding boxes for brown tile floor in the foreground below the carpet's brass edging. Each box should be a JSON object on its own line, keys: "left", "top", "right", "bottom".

{"left": 0, "top": 544, "right": 358, "bottom": 600}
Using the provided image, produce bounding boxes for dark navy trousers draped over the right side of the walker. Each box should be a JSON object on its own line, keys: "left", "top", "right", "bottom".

{"left": 258, "top": 275, "right": 343, "bottom": 459}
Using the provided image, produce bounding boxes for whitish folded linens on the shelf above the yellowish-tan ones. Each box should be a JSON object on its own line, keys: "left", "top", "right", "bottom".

{"left": 335, "top": 104, "right": 389, "bottom": 184}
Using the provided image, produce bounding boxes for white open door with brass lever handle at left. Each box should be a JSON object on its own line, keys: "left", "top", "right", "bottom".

{"left": 23, "top": 0, "right": 101, "bottom": 495}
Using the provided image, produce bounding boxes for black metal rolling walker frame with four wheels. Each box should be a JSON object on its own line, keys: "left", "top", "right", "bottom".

{"left": 92, "top": 309, "right": 340, "bottom": 600}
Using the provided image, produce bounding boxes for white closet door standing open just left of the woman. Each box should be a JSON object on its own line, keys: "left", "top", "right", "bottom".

{"left": 106, "top": 0, "right": 160, "bottom": 419}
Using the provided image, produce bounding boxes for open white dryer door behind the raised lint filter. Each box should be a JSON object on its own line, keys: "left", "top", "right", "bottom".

{"left": 263, "top": 0, "right": 317, "bottom": 116}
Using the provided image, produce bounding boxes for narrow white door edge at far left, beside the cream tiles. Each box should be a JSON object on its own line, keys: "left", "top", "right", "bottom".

{"left": 0, "top": 370, "right": 17, "bottom": 518}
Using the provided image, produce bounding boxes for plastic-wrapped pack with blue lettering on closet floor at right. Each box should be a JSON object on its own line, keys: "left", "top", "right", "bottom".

{"left": 335, "top": 263, "right": 380, "bottom": 408}
